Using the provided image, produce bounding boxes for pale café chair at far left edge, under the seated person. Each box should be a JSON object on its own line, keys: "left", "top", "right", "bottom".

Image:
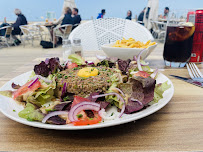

{"left": 0, "top": 26, "right": 16, "bottom": 47}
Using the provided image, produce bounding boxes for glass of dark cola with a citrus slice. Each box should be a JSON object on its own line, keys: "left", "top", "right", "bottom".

{"left": 163, "top": 23, "right": 195, "bottom": 67}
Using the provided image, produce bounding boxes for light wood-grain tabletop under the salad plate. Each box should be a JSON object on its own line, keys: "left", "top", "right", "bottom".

{"left": 0, "top": 49, "right": 203, "bottom": 151}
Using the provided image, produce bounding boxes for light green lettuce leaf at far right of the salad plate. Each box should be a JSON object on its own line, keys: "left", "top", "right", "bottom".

{"left": 153, "top": 81, "right": 171, "bottom": 103}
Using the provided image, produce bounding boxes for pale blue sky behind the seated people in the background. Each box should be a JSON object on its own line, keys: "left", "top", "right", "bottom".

{"left": 0, "top": 0, "right": 203, "bottom": 22}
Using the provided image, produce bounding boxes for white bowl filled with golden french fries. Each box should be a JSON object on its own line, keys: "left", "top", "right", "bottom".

{"left": 101, "top": 38, "right": 157, "bottom": 60}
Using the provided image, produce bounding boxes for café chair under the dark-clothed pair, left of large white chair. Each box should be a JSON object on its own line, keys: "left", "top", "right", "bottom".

{"left": 53, "top": 24, "right": 73, "bottom": 48}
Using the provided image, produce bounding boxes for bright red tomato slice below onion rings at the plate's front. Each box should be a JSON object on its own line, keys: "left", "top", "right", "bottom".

{"left": 73, "top": 112, "right": 102, "bottom": 126}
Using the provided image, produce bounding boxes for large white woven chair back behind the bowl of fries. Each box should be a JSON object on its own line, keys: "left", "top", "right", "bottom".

{"left": 69, "top": 18, "right": 154, "bottom": 51}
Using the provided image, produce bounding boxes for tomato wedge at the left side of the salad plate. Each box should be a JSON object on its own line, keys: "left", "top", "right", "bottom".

{"left": 13, "top": 80, "right": 41, "bottom": 100}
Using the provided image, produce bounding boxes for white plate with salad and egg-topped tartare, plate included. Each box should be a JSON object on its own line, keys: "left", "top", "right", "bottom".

{"left": 0, "top": 51, "right": 174, "bottom": 130}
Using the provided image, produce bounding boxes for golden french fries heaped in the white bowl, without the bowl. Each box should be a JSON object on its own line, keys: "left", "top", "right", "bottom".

{"left": 113, "top": 38, "right": 156, "bottom": 48}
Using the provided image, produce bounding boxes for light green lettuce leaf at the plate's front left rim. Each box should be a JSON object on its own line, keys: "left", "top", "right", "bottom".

{"left": 18, "top": 103, "right": 44, "bottom": 121}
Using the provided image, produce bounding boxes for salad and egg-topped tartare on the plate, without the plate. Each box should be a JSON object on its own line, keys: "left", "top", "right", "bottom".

{"left": 0, "top": 54, "right": 171, "bottom": 125}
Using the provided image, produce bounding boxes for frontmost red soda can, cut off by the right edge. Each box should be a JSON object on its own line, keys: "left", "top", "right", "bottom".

{"left": 190, "top": 9, "right": 203, "bottom": 62}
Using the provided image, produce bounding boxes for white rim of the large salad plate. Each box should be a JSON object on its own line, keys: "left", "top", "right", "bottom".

{"left": 0, "top": 71, "right": 174, "bottom": 130}
